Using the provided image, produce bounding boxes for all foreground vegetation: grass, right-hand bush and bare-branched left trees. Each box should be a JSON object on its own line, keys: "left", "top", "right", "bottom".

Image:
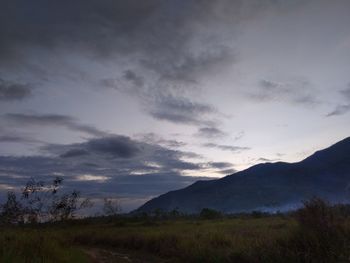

{"left": 0, "top": 182, "right": 350, "bottom": 263}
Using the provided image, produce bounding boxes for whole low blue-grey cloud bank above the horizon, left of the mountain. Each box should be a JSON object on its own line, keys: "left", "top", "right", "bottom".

{"left": 0, "top": 135, "right": 215, "bottom": 211}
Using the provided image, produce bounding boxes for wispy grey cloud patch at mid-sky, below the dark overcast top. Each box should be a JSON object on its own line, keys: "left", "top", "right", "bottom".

{"left": 101, "top": 73, "right": 217, "bottom": 126}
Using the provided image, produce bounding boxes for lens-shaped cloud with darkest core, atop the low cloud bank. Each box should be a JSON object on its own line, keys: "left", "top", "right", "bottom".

{"left": 42, "top": 135, "right": 206, "bottom": 174}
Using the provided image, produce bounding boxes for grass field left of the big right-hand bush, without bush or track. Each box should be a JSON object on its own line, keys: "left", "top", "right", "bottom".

{"left": 0, "top": 217, "right": 295, "bottom": 262}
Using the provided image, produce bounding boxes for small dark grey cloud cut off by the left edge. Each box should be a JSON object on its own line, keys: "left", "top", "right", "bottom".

{"left": 0, "top": 78, "right": 32, "bottom": 101}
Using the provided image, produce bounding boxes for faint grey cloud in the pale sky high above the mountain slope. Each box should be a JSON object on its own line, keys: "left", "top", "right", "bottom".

{"left": 250, "top": 79, "right": 319, "bottom": 106}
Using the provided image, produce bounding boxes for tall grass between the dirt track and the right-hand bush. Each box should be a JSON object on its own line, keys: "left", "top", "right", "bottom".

{"left": 72, "top": 218, "right": 295, "bottom": 262}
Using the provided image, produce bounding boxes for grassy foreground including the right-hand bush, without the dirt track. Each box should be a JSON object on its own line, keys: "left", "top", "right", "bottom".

{"left": 0, "top": 201, "right": 350, "bottom": 263}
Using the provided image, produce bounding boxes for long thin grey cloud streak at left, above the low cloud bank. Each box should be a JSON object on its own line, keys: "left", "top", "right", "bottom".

{"left": 4, "top": 113, "right": 106, "bottom": 136}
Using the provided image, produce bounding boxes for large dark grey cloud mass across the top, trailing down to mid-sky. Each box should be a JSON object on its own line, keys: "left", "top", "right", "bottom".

{"left": 0, "top": 0, "right": 239, "bottom": 128}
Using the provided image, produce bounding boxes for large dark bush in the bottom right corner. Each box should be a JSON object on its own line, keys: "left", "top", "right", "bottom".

{"left": 256, "top": 198, "right": 350, "bottom": 263}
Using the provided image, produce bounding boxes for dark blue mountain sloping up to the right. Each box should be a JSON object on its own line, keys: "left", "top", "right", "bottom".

{"left": 136, "top": 137, "right": 350, "bottom": 213}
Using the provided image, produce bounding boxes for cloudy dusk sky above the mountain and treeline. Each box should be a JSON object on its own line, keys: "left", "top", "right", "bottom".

{"left": 0, "top": 0, "right": 350, "bottom": 211}
